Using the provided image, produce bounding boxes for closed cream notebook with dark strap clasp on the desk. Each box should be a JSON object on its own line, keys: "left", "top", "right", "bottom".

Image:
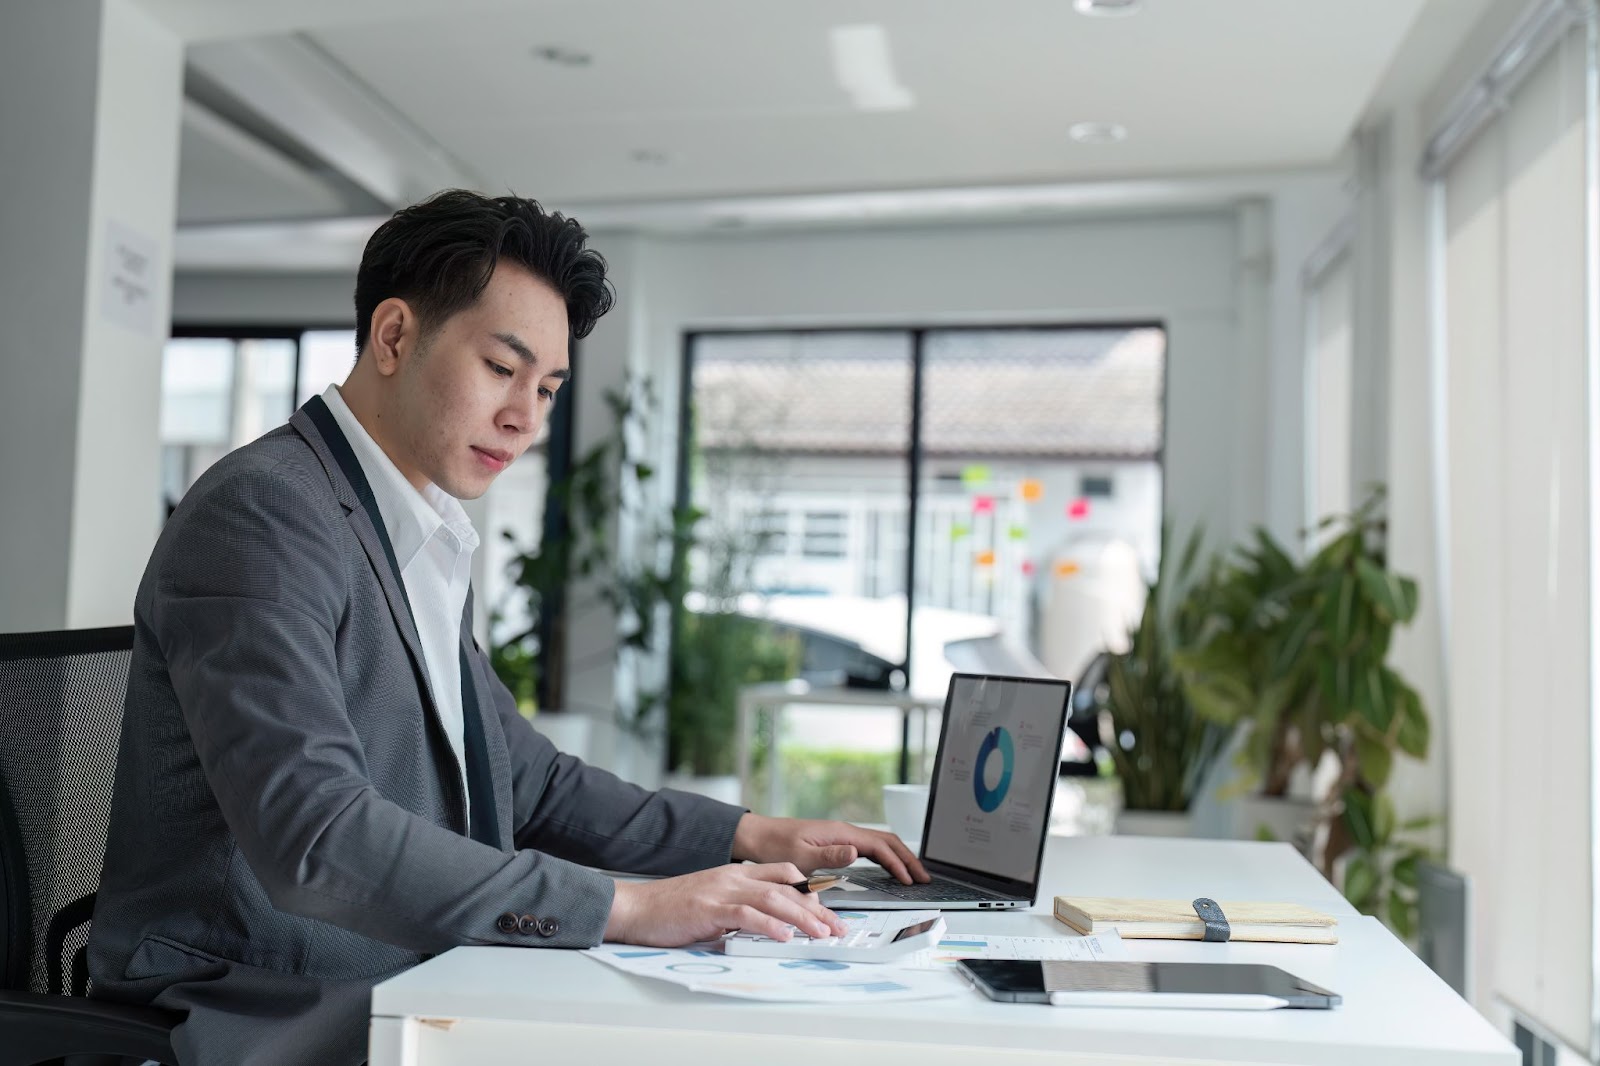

{"left": 1056, "top": 896, "right": 1339, "bottom": 944}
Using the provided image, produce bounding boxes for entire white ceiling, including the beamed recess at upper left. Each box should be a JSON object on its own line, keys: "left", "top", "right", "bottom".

{"left": 141, "top": 0, "right": 1517, "bottom": 261}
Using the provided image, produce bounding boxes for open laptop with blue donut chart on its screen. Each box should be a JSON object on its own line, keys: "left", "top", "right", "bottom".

{"left": 819, "top": 674, "right": 1072, "bottom": 911}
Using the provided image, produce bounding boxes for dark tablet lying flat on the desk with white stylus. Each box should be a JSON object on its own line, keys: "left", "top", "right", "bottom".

{"left": 955, "top": 959, "right": 1339, "bottom": 1010}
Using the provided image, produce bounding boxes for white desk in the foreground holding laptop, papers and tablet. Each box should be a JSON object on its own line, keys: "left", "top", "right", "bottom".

{"left": 371, "top": 837, "right": 1520, "bottom": 1066}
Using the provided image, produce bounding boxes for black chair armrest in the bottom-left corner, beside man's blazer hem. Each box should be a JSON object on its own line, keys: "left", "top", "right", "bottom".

{"left": 0, "top": 991, "right": 184, "bottom": 1066}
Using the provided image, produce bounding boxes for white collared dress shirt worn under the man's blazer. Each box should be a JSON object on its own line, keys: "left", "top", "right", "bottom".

{"left": 322, "top": 386, "right": 478, "bottom": 824}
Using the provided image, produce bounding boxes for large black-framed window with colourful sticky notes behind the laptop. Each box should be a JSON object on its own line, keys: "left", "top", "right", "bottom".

{"left": 669, "top": 325, "right": 1166, "bottom": 809}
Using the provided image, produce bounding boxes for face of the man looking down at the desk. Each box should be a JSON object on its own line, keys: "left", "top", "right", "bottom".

{"left": 384, "top": 261, "right": 568, "bottom": 499}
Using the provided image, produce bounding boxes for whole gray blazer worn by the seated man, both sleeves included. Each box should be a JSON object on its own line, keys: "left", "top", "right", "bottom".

{"left": 88, "top": 400, "right": 742, "bottom": 1066}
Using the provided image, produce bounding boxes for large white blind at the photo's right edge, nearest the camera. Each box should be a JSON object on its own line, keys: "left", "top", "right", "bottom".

{"left": 1443, "top": 24, "right": 1594, "bottom": 1048}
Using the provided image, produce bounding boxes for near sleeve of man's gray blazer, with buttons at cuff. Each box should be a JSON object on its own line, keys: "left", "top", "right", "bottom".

{"left": 144, "top": 466, "right": 614, "bottom": 952}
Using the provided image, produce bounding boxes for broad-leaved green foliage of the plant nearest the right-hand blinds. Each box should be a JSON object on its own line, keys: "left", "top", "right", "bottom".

{"left": 1174, "top": 488, "right": 1430, "bottom": 936}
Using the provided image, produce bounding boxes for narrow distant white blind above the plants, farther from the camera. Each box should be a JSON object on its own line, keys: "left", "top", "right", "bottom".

{"left": 1306, "top": 254, "right": 1354, "bottom": 523}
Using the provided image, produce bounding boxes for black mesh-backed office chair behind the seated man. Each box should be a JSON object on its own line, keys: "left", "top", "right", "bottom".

{"left": 0, "top": 626, "right": 182, "bottom": 1066}
